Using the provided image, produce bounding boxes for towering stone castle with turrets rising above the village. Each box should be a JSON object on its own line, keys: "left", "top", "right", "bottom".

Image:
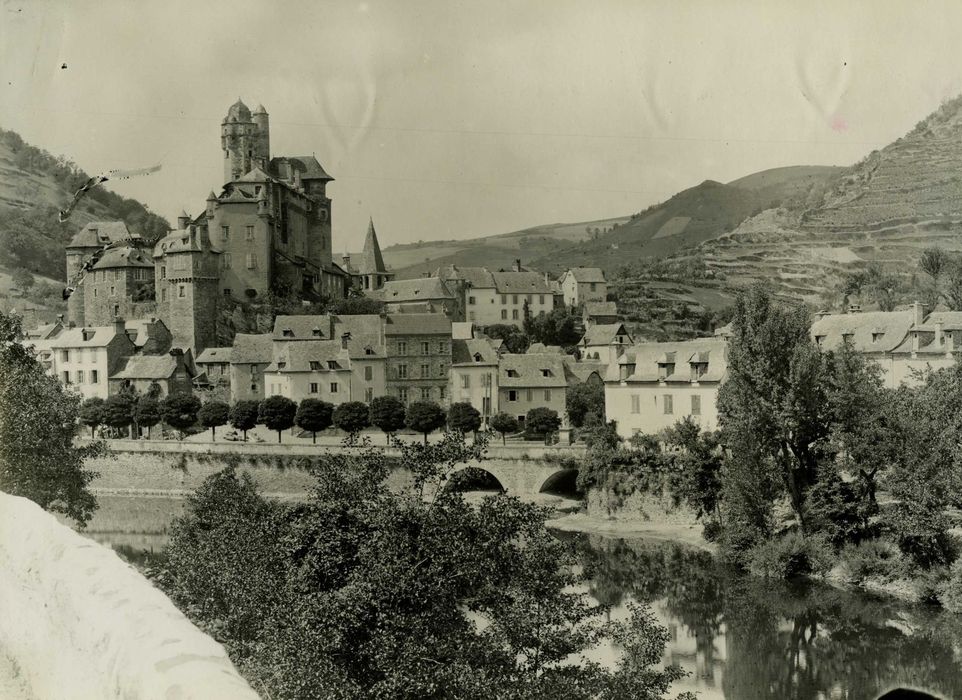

{"left": 67, "top": 100, "right": 360, "bottom": 352}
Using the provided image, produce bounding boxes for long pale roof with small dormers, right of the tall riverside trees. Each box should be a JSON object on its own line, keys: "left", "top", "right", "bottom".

{"left": 811, "top": 310, "right": 915, "bottom": 352}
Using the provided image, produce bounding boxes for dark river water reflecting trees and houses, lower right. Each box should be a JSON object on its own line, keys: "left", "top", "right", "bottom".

{"left": 559, "top": 533, "right": 962, "bottom": 700}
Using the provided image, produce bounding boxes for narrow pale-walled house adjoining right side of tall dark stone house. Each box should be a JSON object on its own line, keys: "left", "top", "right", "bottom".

{"left": 450, "top": 338, "right": 502, "bottom": 428}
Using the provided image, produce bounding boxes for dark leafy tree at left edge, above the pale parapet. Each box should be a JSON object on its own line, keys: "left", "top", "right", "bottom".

{"left": 0, "top": 312, "right": 105, "bottom": 527}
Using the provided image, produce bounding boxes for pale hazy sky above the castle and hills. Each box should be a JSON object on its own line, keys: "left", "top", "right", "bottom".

{"left": 0, "top": 0, "right": 962, "bottom": 252}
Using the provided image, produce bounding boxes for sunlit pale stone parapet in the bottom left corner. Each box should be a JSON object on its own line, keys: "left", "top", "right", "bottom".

{"left": 0, "top": 493, "right": 257, "bottom": 700}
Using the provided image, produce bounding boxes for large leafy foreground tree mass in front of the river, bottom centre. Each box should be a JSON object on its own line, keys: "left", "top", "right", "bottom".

{"left": 155, "top": 436, "right": 682, "bottom": 700}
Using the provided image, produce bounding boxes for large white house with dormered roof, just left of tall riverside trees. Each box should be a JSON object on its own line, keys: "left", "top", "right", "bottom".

{"left": 605, "top": 338, "right": 728, "bottom": 439}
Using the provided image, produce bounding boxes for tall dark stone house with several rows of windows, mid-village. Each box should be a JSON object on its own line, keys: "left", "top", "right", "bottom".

{"left": 384, "top": 313, "right": 451, "bottom": 406}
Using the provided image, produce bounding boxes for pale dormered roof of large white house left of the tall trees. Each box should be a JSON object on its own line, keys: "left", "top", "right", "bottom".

{"left": 607, "top": 338, "right": 728, "bottom": 383}
